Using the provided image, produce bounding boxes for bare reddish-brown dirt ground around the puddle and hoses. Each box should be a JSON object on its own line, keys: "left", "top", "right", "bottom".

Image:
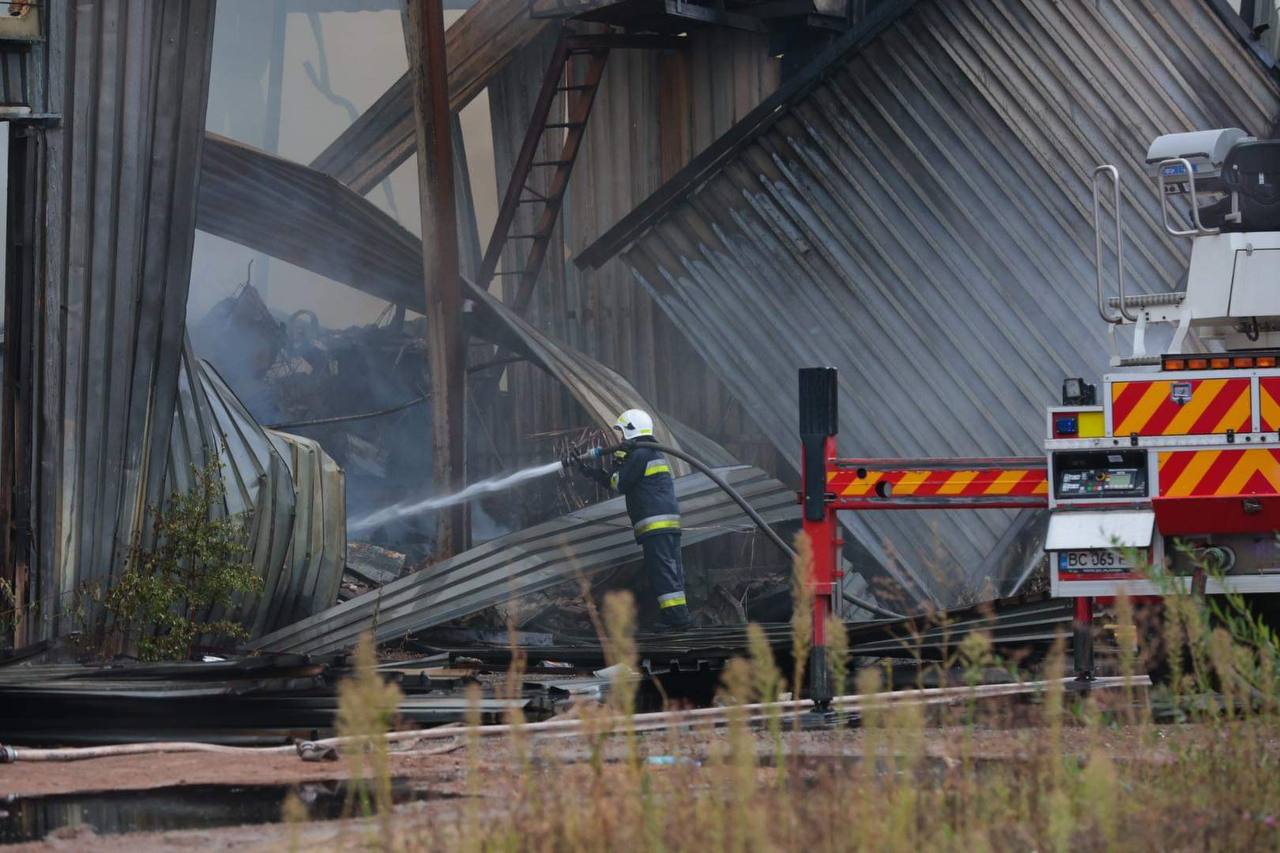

{"left": 0, "top": 727, "right": 1187, "bottom": 853}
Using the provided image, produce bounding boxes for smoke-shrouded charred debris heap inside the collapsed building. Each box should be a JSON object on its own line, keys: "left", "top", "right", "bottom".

{"left": 191, "top": 283, "right": 790, "bottom": 635}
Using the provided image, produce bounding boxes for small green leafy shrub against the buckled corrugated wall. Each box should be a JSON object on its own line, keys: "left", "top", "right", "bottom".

{"left": 105, "top": 457, "right": 262, "bottom": 661}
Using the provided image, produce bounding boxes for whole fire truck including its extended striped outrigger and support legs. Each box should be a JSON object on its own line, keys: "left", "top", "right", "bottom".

{"left": 800, "top": 128, "right": 1280, "bottom": 702}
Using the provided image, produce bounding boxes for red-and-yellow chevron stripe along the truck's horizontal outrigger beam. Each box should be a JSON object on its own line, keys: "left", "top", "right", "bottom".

{"left": 827, "top": 467, "right": 1048, "bottom": 498}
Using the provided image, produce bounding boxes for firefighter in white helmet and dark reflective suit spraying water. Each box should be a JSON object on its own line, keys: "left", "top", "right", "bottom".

{"left": 580, "top": 409, "right": 690, "bottom": 629}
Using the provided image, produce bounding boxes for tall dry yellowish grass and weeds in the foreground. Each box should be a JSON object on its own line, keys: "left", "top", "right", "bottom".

{"left": 317, "top": 537, "right": 1280, "bottom": 852}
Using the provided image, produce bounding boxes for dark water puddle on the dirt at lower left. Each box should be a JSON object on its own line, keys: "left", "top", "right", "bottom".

{"left": 0, "top": 779, "right": 454, "bottom": 844}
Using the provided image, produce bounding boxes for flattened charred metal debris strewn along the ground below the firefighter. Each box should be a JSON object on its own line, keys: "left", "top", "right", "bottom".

{"left": 0, "top": 596, "right": 1080, "bottom": 745}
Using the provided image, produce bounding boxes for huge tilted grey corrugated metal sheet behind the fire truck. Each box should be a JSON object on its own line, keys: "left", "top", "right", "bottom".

{"left": 586, "top": 0, "right": 1280, "bottom": 601}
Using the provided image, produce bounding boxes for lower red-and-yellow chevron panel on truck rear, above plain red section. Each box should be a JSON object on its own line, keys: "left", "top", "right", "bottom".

{"left": 1160, "top": 448, "right": 1280, "bottom": 497}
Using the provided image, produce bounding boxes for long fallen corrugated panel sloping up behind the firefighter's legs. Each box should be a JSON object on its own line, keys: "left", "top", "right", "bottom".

{"left": 251, "top": 466, "right": 799, "bottom": 653}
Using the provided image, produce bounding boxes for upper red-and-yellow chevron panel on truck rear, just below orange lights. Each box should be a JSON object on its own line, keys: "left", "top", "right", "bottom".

{"left": 1111, "top": 378, "right": 1253, "bottom": 435}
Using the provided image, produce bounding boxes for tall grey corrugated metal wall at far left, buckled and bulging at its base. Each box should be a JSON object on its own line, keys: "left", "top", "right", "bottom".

{"left": 0, "top": 0, "right": 346, "bottom": 644}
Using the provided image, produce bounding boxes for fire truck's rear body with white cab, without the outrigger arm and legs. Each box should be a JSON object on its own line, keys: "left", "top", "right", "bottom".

{"left": 1044, "top": 128, "right": 1280, "bottom": 597}
